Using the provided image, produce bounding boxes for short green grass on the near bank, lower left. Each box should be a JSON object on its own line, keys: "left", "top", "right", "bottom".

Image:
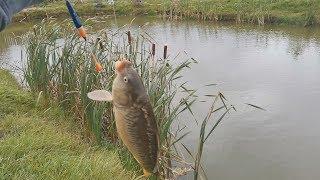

{"left": 0, "top": 70, "right": 134, "bottom": 179}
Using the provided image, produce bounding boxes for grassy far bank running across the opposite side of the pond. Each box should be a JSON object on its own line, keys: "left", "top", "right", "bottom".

{"left": 15, "top": 0, "right": 320, "bottom": 26}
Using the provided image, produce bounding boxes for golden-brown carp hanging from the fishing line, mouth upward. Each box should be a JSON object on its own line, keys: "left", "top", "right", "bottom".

{"left": 87, "top": 60, "right": 159, "bottom": 177}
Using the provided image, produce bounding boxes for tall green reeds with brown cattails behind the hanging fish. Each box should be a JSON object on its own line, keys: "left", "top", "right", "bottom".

{"left": 24, "top": 20, "right": 234, "bottom": 179}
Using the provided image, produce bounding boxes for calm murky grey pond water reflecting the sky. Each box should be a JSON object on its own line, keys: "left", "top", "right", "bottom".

{"left": 0, "top": 18, "right": 320, "bottom": 180}
